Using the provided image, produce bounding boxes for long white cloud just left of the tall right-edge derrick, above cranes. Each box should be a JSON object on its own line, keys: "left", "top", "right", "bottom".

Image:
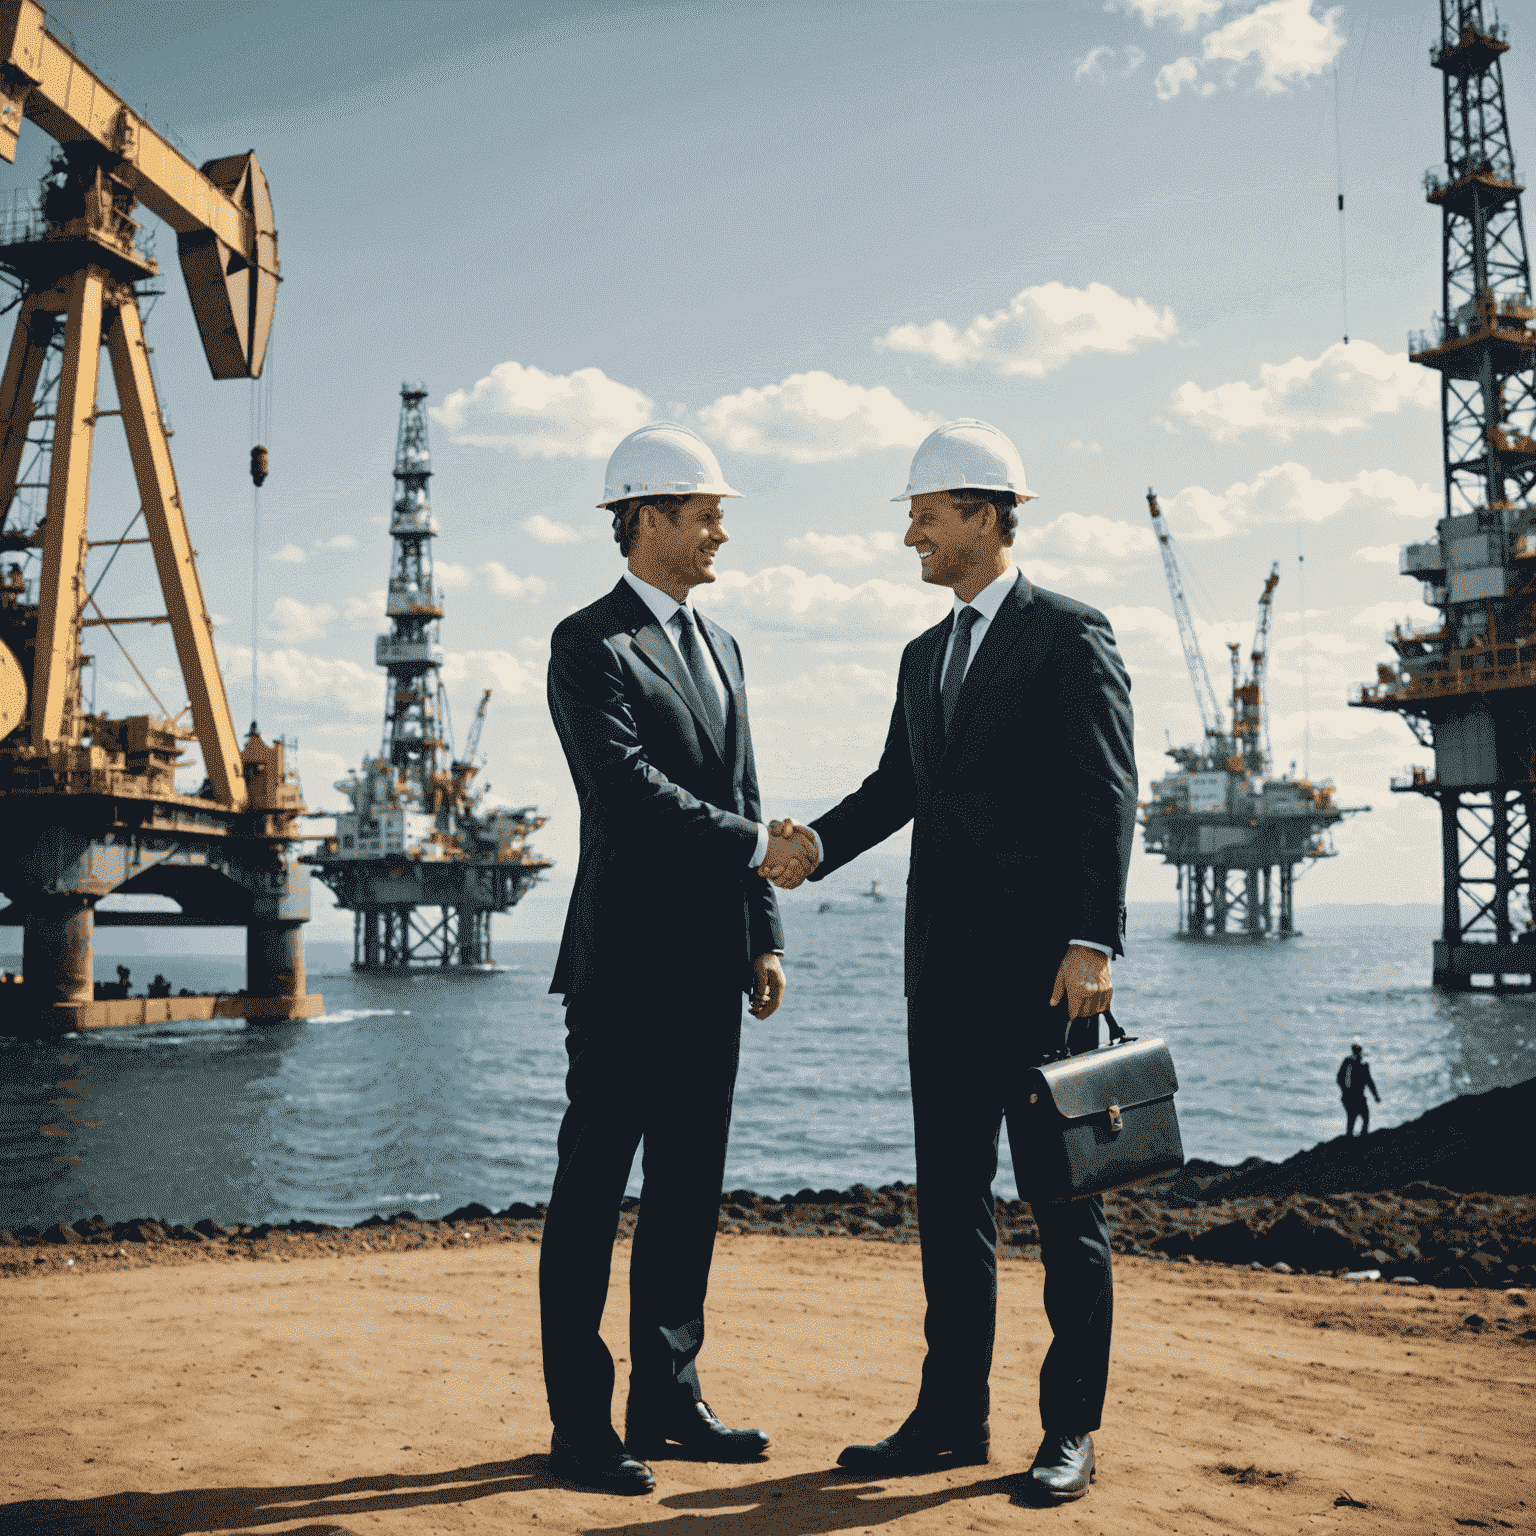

{"left": 1174, "top": 341, "right": 1439, "bottom": 442}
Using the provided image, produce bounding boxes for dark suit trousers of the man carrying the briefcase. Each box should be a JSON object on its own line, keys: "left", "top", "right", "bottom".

{"left": 906, "top": 976, "right": 1114, "bottom": 1435}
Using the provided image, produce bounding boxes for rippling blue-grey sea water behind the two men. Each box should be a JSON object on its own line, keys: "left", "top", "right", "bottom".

{"left": 0, "top": 900, "right": 1536, "bottom": 1227}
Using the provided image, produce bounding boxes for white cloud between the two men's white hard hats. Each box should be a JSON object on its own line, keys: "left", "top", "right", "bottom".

{"left": 699, "top": 369, "right": 940, "bottom": 464}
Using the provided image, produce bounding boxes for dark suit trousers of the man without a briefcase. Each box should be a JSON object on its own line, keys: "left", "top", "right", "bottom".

{"left": 539, "top": 983, "right": 742, "bottom": 1436}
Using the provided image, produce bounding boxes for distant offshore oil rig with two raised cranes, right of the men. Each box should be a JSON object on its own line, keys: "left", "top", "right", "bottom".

{"left": 1141, "top": 490, "right": 1370, "bottom": 942}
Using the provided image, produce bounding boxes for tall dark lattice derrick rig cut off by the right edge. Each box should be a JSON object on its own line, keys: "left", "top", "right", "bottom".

{"left": 1350, "top": 0, "right": 1536, "bottom": 991}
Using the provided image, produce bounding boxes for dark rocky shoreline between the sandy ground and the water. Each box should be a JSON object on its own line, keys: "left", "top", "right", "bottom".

{"left": 0, "top": 1080, "right": 1536, "bottom": 1289}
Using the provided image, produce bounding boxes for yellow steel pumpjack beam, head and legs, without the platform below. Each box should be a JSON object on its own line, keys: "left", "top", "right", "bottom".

{"left": 0, "top": 0, "right": 278, "bottom": 809}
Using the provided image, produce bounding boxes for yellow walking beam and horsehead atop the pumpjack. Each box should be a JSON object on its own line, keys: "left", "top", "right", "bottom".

{"left": 0, "top": 0, "right": 280, "bottom": 379}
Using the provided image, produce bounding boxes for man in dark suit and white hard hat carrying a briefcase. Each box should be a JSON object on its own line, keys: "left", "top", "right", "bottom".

{"left": 776, "top": 421, "right": 1137, "bottom": 1502}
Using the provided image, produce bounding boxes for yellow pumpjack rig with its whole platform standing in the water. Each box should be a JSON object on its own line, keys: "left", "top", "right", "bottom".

{"left": 0, "top": 0, "right": 323, "bottom": 1034}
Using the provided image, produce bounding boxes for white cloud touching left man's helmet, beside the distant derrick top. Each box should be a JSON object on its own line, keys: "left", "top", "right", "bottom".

{"left": 432, "top": 362, "right": 654, "bottom": 459}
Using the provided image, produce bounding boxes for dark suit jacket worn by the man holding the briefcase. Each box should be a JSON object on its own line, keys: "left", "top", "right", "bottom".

{"left": 813, "top": 574, "right": 1137, "bottom": 997}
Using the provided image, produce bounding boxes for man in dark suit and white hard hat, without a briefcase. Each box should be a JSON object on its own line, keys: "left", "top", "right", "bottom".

{"left": 539, "top": 422, "right": 811, "bottom": 1493}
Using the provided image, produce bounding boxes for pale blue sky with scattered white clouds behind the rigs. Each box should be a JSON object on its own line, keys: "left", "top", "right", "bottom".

{"left": 9, "top": 0, "right": 1536, "bottom": 938}
